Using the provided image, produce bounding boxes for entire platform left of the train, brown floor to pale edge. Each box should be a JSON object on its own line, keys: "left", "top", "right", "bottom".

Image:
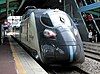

{"left": 0, "top": 37, "right": 48, "bottom": 74}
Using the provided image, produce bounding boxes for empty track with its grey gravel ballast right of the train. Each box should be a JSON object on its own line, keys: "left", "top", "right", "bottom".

{"left": 79, "top": 42, "right": 100, "bottom": 74}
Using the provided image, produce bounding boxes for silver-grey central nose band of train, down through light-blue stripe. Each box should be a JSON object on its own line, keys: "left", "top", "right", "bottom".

{"left": 57, "top": 27, "right": 78, "bottom": 62}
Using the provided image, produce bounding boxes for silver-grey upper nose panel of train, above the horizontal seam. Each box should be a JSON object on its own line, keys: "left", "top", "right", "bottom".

{"left": 57, "top": 27, "right": 76, "bottom": 45}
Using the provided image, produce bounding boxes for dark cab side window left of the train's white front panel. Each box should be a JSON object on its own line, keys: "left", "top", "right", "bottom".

{"left": 40, "top": 14, "right": 53, "bottom": 27}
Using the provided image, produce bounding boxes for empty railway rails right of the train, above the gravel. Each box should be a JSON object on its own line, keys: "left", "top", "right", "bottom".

{"left": 84, "top": 42, "right": 100, "bottom": 62}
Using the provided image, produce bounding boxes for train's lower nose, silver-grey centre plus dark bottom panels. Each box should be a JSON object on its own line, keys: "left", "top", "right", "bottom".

{"left": 42, "top": 28, "right": 80, "bottom": 63}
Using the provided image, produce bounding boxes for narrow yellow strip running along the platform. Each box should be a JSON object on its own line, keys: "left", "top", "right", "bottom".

{"left": 10, "top": 39, "right": 26, "bottom": 74}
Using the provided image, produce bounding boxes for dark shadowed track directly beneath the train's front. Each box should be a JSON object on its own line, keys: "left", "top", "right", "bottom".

{"left": 44, "top": 66, "right": 89, "bottom": 74}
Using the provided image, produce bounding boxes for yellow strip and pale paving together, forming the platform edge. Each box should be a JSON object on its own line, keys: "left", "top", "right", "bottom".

{"left": 9, "top": 38, "right": 48, "bottom": 74}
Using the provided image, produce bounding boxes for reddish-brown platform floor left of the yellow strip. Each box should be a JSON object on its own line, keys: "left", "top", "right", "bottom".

{"left": 0, "top": 37, "right": 17, "bottom": 74}
